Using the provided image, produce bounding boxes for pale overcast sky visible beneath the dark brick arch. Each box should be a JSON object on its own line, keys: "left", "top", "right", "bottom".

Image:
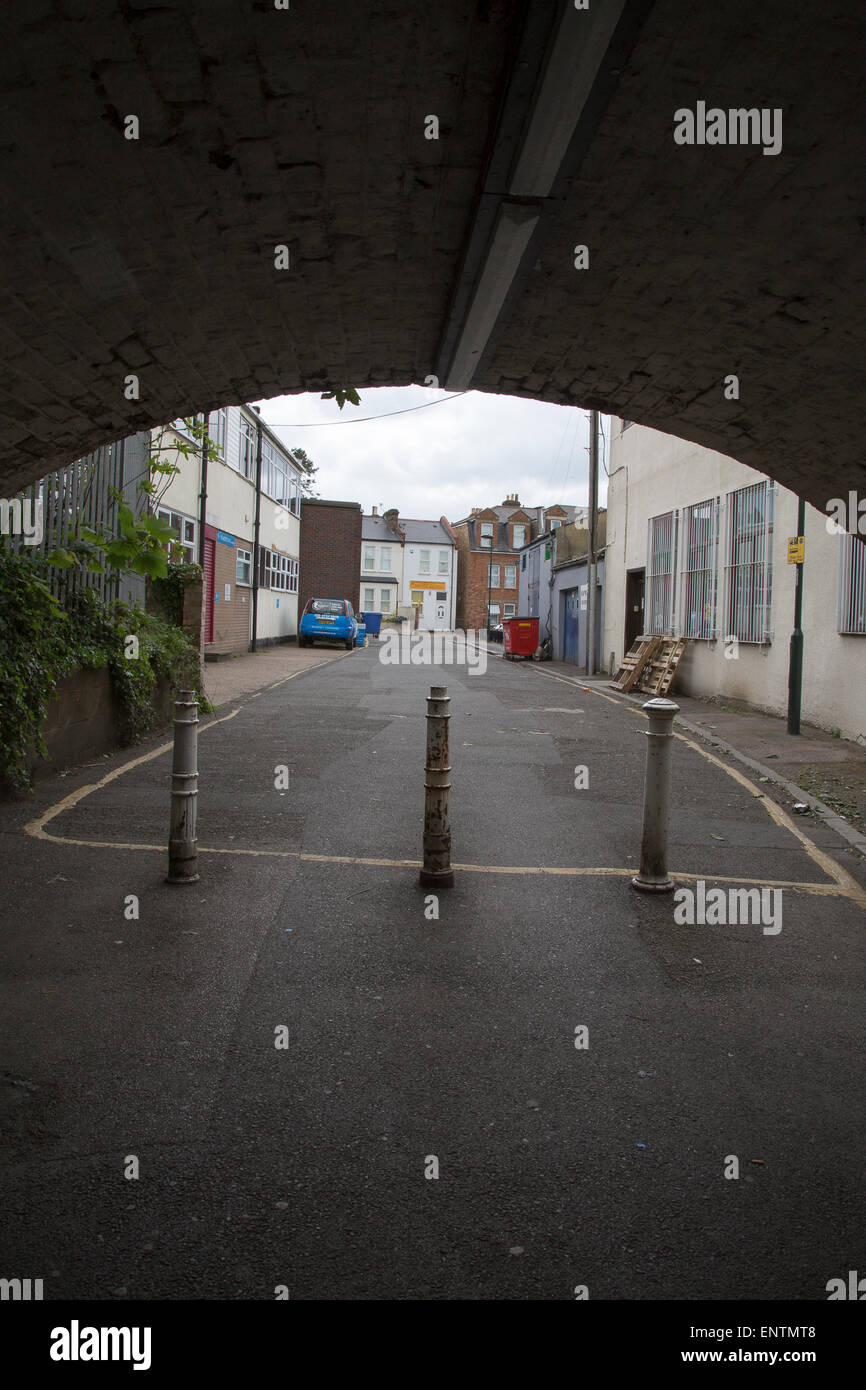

{"left": 257, "top": 386, "right": 610, "bottom": 521}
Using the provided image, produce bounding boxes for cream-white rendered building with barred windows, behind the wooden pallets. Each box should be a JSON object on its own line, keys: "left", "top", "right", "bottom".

{"left": 603, "top": 423, "right": 866, "bottom": 742}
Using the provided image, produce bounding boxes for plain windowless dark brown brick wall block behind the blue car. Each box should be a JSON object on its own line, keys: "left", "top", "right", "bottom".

{"left": 297, "top": 498, "right": 361, "bottom": 613}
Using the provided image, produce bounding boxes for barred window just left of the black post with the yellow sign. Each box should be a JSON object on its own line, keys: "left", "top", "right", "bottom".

{"left": 723, "top": 482, "right": 774, "bottom": 642}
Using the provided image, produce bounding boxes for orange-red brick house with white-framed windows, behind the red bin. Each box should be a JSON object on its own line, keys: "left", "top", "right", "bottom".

{"left": 452, "top": 493, "right": 578, "bottom": 628}
